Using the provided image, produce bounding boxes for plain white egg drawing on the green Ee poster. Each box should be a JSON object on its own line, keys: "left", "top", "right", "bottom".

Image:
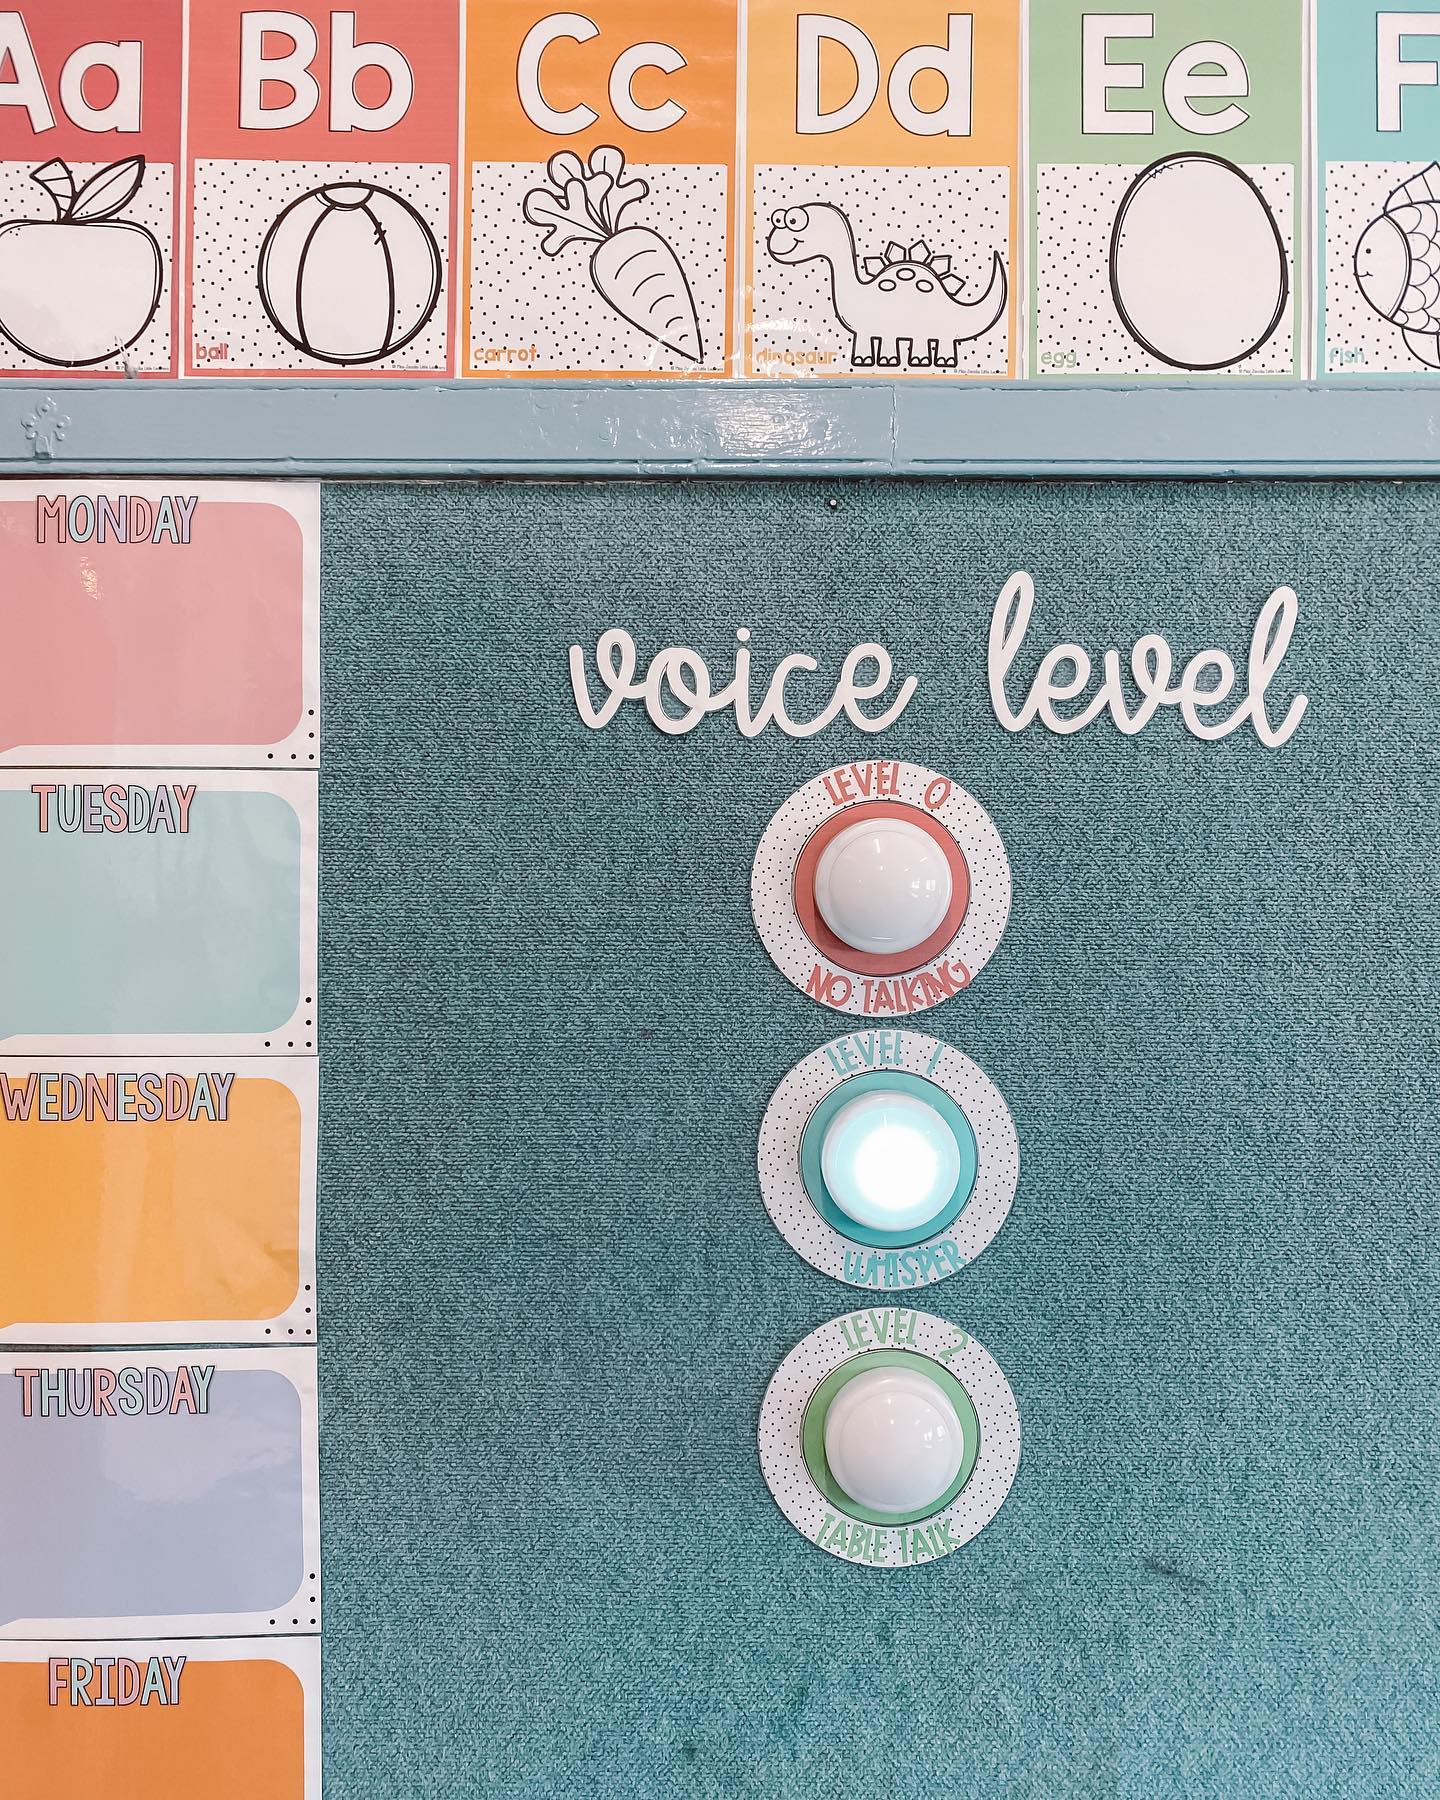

{"left": 1111, "top": 153, "right": 1291, "bottom": 371}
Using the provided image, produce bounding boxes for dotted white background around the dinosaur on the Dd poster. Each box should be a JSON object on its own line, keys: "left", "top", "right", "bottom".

{"left": 751, "top": 164, "right": 1015, "bottom": 378}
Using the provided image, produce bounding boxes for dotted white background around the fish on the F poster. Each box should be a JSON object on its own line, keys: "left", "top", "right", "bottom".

{"left": 1319, "top": 162, "right": 1435, "bottom": 380}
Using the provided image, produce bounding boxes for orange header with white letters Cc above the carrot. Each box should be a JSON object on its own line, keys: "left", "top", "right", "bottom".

{"left": 466, "top": 0, "right": 740, "bottom": 167}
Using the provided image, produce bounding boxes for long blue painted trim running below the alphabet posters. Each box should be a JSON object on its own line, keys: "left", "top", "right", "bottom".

{"left": 0, "top": 380, "right": 1440, "bottom": 477}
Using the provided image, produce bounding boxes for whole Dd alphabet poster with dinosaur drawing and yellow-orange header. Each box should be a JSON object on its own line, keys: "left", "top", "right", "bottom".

{"left": 747, "top": 0, "right": 1021, "bottom": 380}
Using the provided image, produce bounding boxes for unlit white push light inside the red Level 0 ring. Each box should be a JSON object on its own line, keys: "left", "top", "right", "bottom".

{"left": 815, "top": 819, "right": 950, "bottom": 956}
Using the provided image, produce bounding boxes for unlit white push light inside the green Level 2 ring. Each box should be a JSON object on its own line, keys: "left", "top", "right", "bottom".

{"left": 824, "top": 1368, "right": 965, "bottom": 1514}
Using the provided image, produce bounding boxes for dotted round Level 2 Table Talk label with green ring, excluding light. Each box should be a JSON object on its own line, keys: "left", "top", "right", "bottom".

{"left": 760, "top": 1307, "right": 1021, "bottom": 1568}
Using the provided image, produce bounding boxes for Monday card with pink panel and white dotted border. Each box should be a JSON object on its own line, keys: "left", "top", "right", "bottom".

{"left": 0, "top": 481, "right": 320, "bottom": 769}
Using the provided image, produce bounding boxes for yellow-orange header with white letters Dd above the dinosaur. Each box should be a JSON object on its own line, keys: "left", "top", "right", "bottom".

{"left": 747, "top": 0, "right": 1021, "bottom": 167}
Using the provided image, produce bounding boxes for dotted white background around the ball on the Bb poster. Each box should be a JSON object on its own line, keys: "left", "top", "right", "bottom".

{"left": 191, "top": 158, "right": 450, "bottom": 376}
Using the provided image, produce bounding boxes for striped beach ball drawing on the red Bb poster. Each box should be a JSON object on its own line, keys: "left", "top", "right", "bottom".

{"left": 259, "top": 182, "right": 441, "bottom": 364}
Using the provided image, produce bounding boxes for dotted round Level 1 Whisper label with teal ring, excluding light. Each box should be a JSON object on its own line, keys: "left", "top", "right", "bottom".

{"left": 760, "top": 1028, "right": 1021, "bottom": 1292}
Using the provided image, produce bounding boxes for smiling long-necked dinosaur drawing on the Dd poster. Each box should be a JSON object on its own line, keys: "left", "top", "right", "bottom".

{"left": 765, "top": 200, "right": 1010, "bottom": 369}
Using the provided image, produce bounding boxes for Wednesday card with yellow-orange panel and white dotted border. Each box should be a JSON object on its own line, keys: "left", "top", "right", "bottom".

{"left": 0, "top": 1057, "right": 319, "bottom": 1345}
